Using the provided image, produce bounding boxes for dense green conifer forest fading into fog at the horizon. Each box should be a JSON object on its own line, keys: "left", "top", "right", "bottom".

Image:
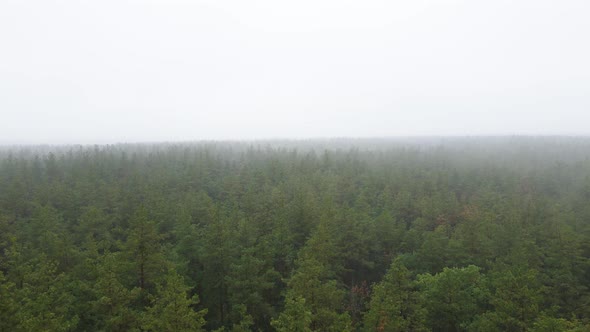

{"left": 0, "top": 137, "right": 590, "bottom": 332}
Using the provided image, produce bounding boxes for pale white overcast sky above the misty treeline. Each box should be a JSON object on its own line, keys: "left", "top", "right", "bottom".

{"left": 0, "top": 0, "right": 590, "bottom": 144}
